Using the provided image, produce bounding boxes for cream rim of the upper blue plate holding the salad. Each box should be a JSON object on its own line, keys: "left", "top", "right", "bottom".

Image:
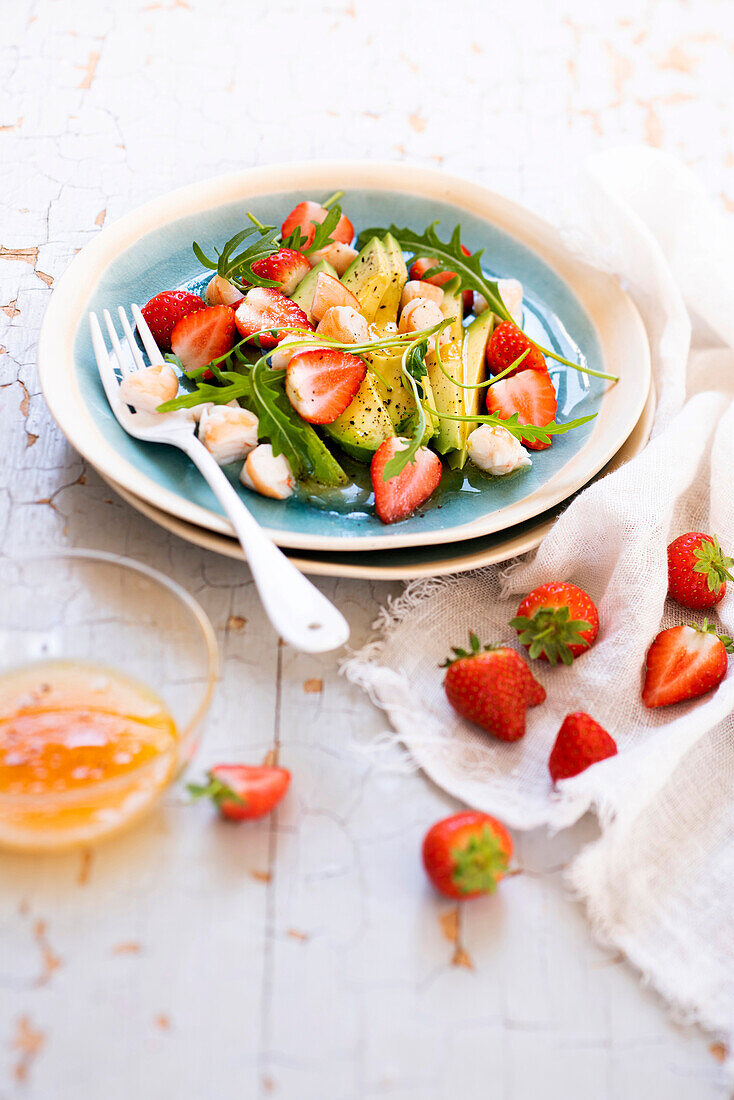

{"left": 39, "top": 160, "right": 651, "bottom": 552}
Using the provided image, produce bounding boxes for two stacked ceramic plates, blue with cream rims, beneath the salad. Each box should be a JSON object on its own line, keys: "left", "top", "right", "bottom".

{"left": 39, "top": 163, "right": 654, "bottom": 580}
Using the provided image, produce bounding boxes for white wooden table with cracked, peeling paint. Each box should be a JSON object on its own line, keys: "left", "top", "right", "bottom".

{"left": 0, "top": 0, "right": 734, "bottom": 1100}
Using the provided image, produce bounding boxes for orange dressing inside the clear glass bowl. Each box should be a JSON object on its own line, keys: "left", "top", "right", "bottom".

{"left": 0, "top": 661, "right": 178, "bottom": 849}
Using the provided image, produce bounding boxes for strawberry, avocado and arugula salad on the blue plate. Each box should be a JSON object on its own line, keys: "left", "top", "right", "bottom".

{"left": 121, "top": 193, "right": 615, "bottom": 524}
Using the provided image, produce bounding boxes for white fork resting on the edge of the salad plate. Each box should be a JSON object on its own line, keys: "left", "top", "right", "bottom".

{"left": 89, "top": 306, "right": 349, "bottom": 653}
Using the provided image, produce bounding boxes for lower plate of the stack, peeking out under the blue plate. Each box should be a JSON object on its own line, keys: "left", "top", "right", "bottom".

{"left": 102, "top": 387, "right": 655, "bottom": 581}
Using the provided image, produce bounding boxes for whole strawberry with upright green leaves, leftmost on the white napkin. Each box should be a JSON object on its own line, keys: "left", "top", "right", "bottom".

{"left": 442, "top": 634, "right": 546, "bottom": 741}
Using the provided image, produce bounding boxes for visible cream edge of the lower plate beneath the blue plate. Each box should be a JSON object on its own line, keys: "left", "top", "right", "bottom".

{"left": 100, "top": 383, "right": 657, "bottom": 583}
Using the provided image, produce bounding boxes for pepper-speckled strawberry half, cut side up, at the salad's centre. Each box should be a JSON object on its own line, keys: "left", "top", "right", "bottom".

{"left": 285, "top": 348, "right": 366, "bottom": 424}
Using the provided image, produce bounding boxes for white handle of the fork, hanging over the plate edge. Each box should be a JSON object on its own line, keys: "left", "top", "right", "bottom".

{"left": 179, "top": 437, "right": 349, "bottom": 653}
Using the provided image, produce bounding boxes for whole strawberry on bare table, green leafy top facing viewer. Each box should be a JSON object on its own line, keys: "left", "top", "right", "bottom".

{"left": 423, "top": 810, "right": 513, "bottom": 900}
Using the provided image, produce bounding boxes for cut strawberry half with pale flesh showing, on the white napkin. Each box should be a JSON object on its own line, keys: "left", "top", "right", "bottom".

{"left": 643, "top": 622, "right": 734, "bottom": 707}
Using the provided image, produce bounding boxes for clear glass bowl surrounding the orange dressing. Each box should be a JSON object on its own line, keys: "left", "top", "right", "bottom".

{"left": 0, "top": 550, "right": 219, "bottom": 851}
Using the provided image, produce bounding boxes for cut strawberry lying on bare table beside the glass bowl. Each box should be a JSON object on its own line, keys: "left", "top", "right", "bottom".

{"left": 187, "top": 763, "right": 291, "bottom": 822}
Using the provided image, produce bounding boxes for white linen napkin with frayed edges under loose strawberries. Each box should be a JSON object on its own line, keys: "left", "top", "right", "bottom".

{"left": 344, "top": 147, "right": 734, "bottom": 1068}
